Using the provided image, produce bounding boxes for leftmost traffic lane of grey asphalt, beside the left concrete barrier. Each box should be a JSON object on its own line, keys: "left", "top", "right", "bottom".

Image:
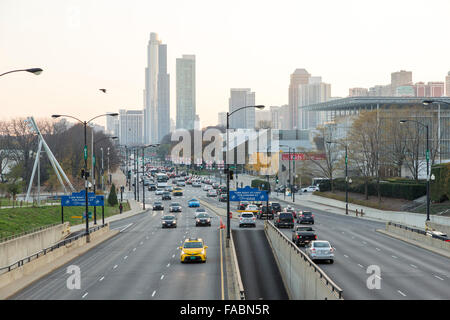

{"left": 12, "top": 209, "right": 162, "bottom": 300}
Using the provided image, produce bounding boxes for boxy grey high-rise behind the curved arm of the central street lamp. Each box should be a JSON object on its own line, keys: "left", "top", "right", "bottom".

{"left": 228, "top": 88, "right": 255, "bottom": 129}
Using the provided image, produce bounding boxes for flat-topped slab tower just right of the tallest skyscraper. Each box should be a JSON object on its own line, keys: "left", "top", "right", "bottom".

{"left": 176, "top": 55, "right": 196, "bottom": 130}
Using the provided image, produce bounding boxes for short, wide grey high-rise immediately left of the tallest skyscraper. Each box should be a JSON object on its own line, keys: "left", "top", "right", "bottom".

{"left": 118, "top": 109, "right": 144, "bottom": 146}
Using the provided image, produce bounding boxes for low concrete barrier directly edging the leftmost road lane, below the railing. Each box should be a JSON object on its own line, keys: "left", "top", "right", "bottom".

{"left": 0, "top": 225, "right": 109, "bottom": 299}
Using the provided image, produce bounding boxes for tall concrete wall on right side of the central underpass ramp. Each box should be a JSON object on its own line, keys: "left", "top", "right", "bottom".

{"left": 264, "top": 221, "right": 343, "bottom": 300}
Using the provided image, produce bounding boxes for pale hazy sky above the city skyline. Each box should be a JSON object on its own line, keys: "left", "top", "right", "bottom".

{"left": 0, "top": 0, "right": 450, "bottom": 126}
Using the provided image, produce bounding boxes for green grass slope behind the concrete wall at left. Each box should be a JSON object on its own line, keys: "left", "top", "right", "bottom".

{"left": 0, "top": 202, "right": 130, "bottom": 238}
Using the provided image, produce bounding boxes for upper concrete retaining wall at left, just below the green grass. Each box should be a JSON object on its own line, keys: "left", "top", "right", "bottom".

{"left": 0, "top": 222, "right": 70, "bottom": 268}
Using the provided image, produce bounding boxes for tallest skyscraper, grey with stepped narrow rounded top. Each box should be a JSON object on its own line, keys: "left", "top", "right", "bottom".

{"left": 143, "top": 32, "right": 170, "bottom": 144}
